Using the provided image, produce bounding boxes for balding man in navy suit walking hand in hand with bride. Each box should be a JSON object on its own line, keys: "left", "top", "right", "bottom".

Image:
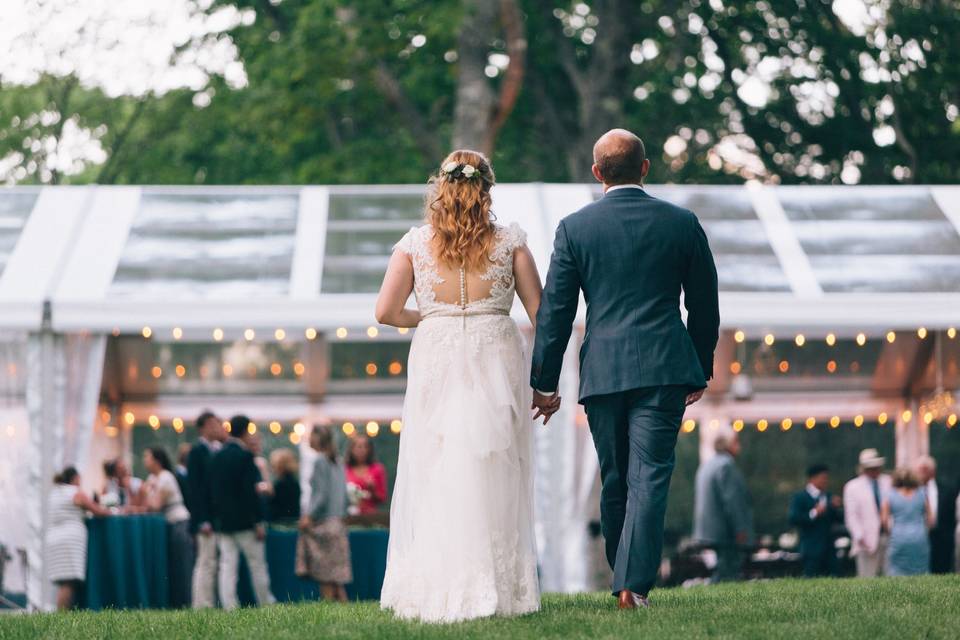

{"left": 530, "top": 129, "right": 720, "bottom": 609}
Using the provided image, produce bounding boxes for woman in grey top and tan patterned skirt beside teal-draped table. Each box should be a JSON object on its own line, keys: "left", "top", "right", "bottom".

{"left": 296, "top": 425, "right": 353, "bottom": 602}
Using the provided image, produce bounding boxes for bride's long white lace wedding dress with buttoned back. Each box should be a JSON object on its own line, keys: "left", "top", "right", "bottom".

{"left": 381, "top": 225, "right": 540, "bottom": 622}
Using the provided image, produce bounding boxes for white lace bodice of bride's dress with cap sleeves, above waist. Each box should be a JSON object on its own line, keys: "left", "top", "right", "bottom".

{"left": 396, "top": 223, "right": 527, "bottom": 318}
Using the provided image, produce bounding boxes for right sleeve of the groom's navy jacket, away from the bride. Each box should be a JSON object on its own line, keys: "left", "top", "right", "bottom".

{"left": 683, "top": 214, "right": 720, "bottom": 380}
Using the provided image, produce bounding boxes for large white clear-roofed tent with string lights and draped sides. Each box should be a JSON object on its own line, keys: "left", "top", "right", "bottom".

{"left": 0, "top": 184, "right": 960, "bottom": 606}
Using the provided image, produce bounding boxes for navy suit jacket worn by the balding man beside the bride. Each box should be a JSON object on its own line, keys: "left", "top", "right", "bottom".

{"left": 530, "top": 188, "right": 720, "bottom": 402}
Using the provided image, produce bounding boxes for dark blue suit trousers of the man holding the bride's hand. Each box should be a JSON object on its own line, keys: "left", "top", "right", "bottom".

{"left": 583, "top": 385, "right": 689, "bottom": 595}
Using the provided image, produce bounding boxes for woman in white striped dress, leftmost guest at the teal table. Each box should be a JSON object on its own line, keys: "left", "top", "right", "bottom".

{"left": 46, "top": 467, "right": 110, "bottom": 611}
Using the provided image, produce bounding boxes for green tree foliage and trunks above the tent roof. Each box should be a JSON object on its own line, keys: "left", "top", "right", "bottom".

{"left": 0, "top": 0, "right": 960, "bottom": 184}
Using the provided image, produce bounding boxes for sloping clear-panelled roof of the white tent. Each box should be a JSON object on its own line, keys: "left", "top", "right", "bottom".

{"left": 0, "top": 184, "right": 960, "bottom": 332}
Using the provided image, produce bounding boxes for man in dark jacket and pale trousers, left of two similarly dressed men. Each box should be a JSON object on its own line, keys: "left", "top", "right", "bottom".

{"left": 186, "top": 411, "right": 227, "bottom": 609}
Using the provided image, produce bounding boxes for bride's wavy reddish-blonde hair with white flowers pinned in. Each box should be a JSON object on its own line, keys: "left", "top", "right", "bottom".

{"left": 424, "top": 149, "right": 497, "bottom": 270}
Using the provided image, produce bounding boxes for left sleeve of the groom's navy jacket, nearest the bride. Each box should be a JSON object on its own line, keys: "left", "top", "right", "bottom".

{"left": 530, "top": 221, "right": 580, "bottom": 392}
